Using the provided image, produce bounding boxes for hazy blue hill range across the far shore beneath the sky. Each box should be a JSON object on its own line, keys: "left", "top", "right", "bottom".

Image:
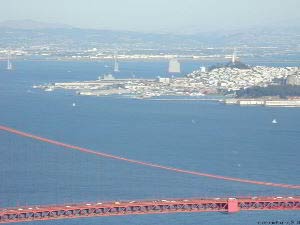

{"left": 0, "top": 20, "right": 300, "bottom": 59}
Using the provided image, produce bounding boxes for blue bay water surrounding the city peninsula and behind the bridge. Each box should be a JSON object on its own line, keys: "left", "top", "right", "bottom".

{"left": 0, "top": 61, "right": 300, "bottom": 225}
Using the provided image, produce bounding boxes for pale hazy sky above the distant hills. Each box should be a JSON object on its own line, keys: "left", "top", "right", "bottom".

{"left": 0, "top": 0, "right": 300, "bottom": 32}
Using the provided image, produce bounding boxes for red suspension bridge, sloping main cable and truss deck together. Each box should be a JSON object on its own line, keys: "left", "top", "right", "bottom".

{"left": 0, "top": 125, "right": 300, "bottom": 223}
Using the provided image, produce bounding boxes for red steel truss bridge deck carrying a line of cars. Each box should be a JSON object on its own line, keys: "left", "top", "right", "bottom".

{"left": 0, "top": 196, "right": 300, "bottom": 224}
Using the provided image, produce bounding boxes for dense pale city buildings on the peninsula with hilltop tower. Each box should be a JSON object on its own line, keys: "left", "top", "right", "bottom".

{"left": 36, "top": 56, "right": 299, "bottom": 98}
